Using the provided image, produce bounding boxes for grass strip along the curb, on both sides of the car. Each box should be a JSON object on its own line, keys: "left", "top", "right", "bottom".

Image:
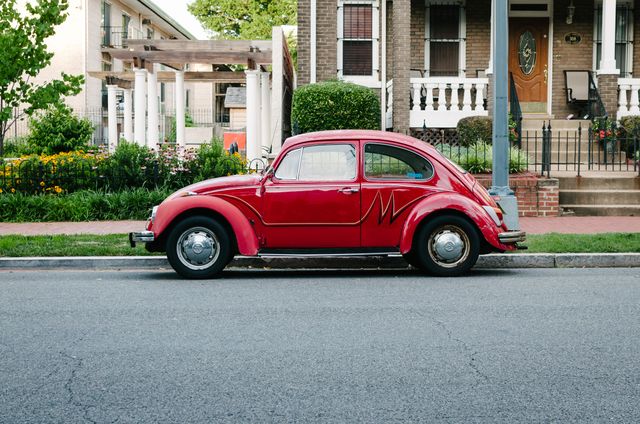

{"left": 0, "top": 233, "right": 640, "bottom": 257}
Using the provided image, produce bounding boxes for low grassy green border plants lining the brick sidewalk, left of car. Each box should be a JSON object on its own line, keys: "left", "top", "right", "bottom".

{"left": 0, "top": 188, "right": 172, "bottom": 222}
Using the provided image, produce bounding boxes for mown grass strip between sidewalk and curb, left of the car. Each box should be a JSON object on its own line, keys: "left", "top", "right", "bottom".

{"left": 0, "top": 234, "right": 159, "bottom": 257}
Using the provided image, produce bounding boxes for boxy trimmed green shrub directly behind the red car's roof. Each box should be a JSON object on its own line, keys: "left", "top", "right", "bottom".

{"left": 291, "top": 81, "right": 380, "bottom": 134}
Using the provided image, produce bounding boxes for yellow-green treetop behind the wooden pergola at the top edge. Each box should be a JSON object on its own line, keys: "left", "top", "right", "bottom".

{"left": 189, "top": 0, "right": 297, "bottom": 40}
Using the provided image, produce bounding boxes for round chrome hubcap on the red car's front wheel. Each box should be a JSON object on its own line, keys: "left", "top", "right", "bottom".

{"left": 177, "top": 227, "right": 220, "bottom": 270}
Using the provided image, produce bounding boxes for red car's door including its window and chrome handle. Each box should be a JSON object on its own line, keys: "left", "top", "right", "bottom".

{"left": 263, "top": 141, "right": 360, "bottom": 249}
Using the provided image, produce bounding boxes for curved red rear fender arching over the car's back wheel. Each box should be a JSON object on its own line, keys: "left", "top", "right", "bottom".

{"left": 400, "top": 192, "right": 509, "bottom": 254}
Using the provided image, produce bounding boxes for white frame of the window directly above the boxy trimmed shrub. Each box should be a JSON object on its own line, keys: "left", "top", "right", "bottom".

{"left": 337, "top": 0, "right": 381, "bottom": 88}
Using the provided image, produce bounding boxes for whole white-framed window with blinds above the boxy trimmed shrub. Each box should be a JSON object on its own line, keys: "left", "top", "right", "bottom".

{"left": 338, "top": 0, "right": 380, "bottom": 83}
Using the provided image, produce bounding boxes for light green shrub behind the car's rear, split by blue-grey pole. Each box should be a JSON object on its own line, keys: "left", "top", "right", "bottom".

{"left": 435, "top": 142, "right": 529, "bottom": 174}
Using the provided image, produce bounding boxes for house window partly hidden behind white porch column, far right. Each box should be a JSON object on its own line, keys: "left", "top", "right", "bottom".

{"left": 593, "top": 3, "right": 633, "bottom": 77}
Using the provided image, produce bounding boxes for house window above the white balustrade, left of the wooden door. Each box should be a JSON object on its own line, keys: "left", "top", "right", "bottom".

{"left": 424, "top": 1, "right": 466, "bottom": 77}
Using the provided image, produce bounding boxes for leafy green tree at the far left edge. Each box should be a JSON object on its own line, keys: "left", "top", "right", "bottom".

{"left": 0, "top": 0, "right": 84, "bottom": 156}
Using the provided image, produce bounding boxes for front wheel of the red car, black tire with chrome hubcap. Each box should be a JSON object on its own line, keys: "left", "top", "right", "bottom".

{"left": 167, "top": 216, "right": 232, "bottom": 279}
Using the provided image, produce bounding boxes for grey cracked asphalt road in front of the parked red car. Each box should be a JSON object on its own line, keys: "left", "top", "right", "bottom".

{"left": 0, "top": 268, "right": 640, "bottom": 423}
